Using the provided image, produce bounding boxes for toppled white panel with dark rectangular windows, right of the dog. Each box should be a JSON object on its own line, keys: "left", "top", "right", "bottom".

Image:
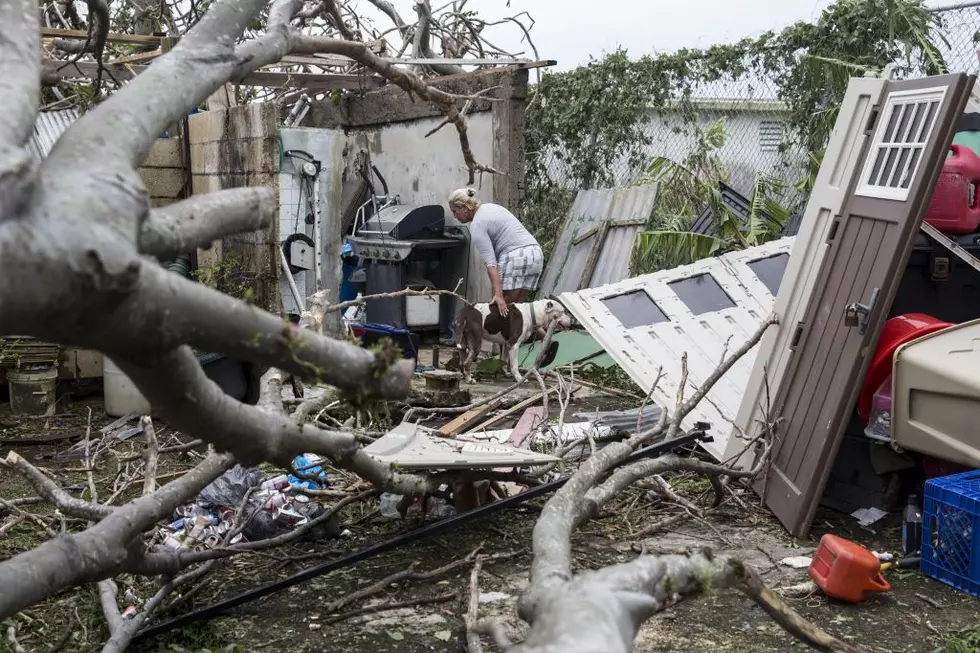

{"left": 560, "top": 237, "right": 795, "bottom": 460}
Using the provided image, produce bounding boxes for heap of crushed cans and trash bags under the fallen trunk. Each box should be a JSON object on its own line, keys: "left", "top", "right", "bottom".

{"left": 154, "top": 454, "right": 341, "bottom": 549}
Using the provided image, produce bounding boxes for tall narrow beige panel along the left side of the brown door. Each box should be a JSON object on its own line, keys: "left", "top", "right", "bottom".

{"left": 725, "top": 78, "right": 885, "bottom": 468}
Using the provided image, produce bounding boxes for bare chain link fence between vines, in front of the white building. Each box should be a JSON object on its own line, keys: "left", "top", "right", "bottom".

{"left": 525, "top": 2, "right": 980, "bottom": 237}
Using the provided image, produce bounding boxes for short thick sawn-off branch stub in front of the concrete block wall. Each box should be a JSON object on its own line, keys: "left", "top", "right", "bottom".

{"left": 139, "top": 188, "right": 279, "bottom": 261}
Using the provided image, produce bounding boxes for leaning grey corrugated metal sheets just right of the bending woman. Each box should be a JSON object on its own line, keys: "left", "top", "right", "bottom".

{"left": 538, "top": 184, "right": 659, "bottom": 296}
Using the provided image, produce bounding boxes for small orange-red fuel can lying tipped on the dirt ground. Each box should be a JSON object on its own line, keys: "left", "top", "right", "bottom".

{"left": 808, "top": 533, "right": 892, "bottom": 603}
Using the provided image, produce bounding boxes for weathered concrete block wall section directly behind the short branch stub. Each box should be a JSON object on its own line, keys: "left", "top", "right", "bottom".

{"left": 188, "top": 103, "right": 282, "bottom": 313}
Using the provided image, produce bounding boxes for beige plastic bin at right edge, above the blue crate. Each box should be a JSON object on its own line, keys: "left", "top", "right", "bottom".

{"left": 892, "top": 320, "right": 980, "bottom": 467}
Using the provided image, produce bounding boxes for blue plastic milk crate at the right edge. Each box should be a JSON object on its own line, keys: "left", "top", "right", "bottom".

{"left": 921, "top": 471, "right": 980, "bottom": 597}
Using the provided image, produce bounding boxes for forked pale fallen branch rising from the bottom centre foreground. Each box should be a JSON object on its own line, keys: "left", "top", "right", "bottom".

{"left": 508, "top": 317, "right": 858, "bottom": 653}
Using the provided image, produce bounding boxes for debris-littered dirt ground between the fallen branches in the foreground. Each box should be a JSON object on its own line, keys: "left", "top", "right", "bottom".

{"left": 0, "top": 388, "right": 980, "bottom": 653}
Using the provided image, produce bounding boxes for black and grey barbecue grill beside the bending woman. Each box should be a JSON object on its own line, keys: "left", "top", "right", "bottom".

{"left": 347, "top": 200, "right": 469, "bottom": 334}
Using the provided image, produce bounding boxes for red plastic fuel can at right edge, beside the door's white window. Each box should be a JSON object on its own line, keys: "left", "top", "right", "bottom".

{"left": 923, "top": 143, "right": 980, "bottom": 234}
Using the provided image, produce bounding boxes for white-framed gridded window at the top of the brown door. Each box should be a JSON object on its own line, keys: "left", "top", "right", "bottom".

{"left": 854, "top": 86, "right": 946, "bottom": 202}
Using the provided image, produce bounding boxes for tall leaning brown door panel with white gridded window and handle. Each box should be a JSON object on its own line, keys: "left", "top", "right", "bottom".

{"left": 756, "top": 74, "right": 973, "bottom": 537}
